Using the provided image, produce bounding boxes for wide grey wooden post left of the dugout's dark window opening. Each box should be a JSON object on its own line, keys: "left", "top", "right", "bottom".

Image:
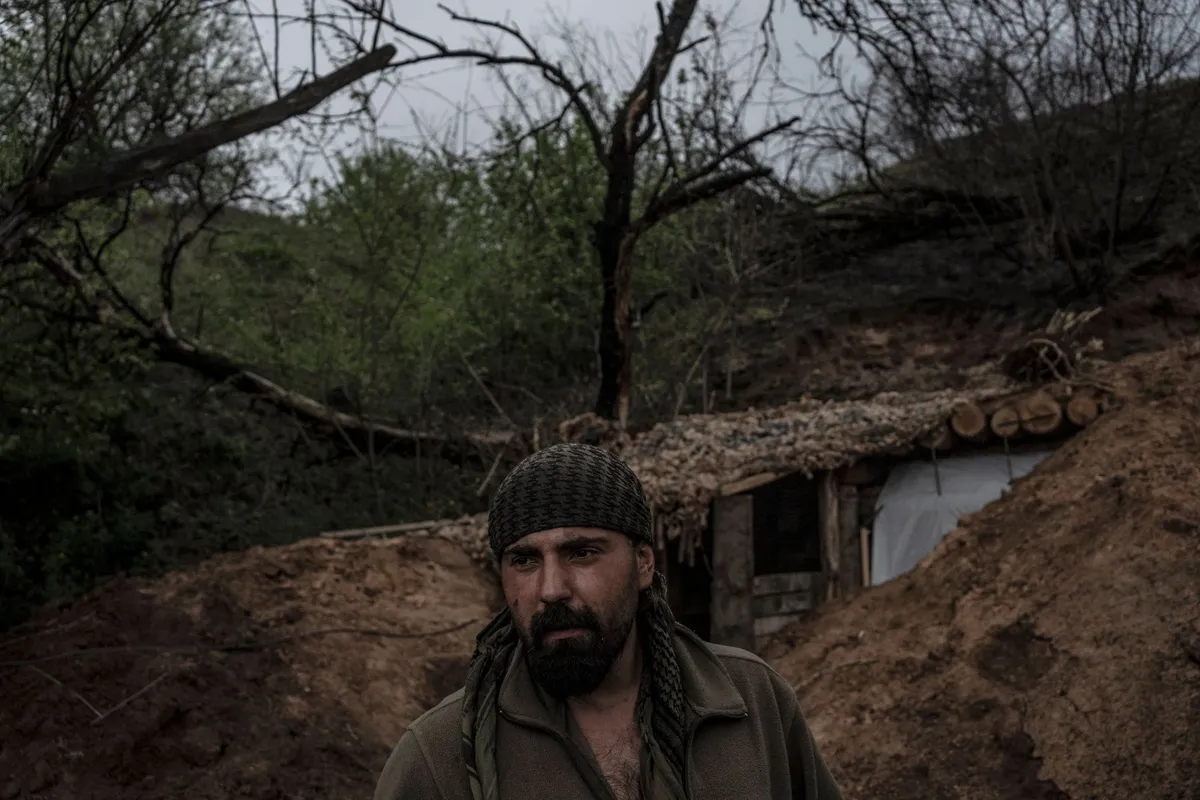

{"left": 709, "top": 494, "right": 755, "bottom": 651}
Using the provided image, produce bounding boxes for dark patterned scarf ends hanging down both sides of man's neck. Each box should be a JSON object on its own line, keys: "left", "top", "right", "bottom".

{"left": 462, "top": 572, "right": 685, "bottom": 800}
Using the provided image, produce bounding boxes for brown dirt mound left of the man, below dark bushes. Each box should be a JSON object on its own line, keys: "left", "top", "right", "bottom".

{"left": 0, "top": 539, "right": 499, "bottom": 800}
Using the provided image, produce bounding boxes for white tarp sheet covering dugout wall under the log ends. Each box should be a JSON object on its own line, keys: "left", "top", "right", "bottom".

{"left": 871, "top": 452, "right": 1050, "bottom": 585}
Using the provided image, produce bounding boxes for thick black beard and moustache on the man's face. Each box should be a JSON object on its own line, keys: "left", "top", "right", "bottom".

{"left": 523, "top": 603, "right": 636, "bottom": 700}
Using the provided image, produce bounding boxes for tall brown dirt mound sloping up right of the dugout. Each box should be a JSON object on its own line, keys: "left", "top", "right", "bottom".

{"left": 767, "top": 343, "right": 1200, "bottom": 800}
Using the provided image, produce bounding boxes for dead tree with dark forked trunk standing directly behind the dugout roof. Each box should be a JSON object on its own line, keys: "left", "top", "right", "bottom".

{"left": 346, "top": 0, "right": 799, "bottom": 427}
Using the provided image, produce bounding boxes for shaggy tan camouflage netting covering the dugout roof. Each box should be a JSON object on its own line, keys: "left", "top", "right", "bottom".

{"left": 620, "top": 390, "right": 1001, "bottom": 555}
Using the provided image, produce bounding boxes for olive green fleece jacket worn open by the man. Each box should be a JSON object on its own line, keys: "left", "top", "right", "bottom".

{"left": 374, "top": 627, "right": 841, "bottom": 800}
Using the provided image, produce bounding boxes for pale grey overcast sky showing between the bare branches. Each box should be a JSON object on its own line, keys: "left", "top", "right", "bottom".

{"left": 253, "top": 0, "right": 854, "bottom": 196}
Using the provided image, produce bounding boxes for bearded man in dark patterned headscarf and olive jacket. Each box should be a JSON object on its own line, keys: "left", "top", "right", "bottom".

{"left": 374, "top": 444, "right": 841, "bottom": 800}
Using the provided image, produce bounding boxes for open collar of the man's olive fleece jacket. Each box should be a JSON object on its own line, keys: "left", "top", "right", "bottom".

{"left": 499, "top": 625, "right": 746, "bottom": 734}
